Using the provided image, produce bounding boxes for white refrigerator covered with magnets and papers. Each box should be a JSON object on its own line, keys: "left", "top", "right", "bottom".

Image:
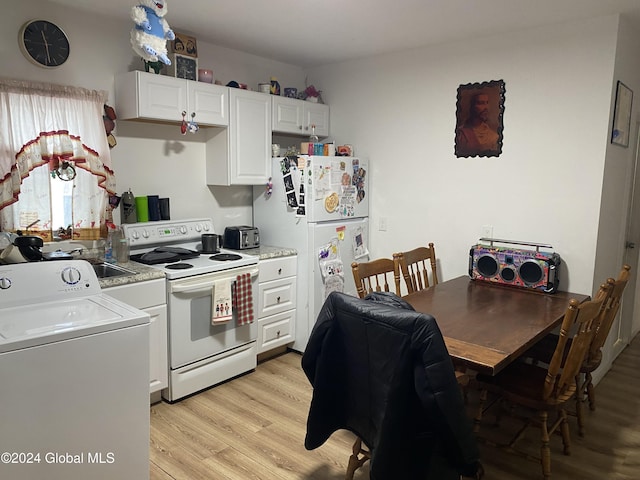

{"left": 253, "top": 155, "right": 371, "bottom": 352}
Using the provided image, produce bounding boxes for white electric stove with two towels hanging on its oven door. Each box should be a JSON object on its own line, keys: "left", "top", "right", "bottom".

{"left": 123, "top": 219, "right": 258, "bottom": 402}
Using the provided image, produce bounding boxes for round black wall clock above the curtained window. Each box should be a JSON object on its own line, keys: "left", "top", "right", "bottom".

{"left": 18, "top": 20, "right": 70, "bottom": 68}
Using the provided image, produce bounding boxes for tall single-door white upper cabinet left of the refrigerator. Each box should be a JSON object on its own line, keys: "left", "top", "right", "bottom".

{"left": 206, "top": 88, "right": 271, "bottom": 185}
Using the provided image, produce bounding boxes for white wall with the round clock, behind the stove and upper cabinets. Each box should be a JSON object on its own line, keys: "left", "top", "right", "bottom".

{"left": 0, "top": 0, "right": 305, "bottom": 234}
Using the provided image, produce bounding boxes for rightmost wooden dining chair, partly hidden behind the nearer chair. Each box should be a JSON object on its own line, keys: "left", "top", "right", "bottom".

{"left": 523, "top": 265, "right": 631, "bottom": 436}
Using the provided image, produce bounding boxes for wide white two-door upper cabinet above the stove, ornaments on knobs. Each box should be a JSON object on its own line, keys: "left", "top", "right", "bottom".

{"left": 116, "top": 71, "right": 229, "bottom": 126}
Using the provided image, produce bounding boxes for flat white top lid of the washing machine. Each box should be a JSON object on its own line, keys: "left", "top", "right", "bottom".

{"left": 0, "top": 295, "right": 149, "bottom": 353}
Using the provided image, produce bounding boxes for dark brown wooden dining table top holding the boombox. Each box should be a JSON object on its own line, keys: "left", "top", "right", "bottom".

{"left": 402, "top": 275, "right": 590, "bottom": 375}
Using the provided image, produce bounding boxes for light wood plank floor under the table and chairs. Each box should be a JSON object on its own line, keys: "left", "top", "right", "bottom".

{"left": 150, "top": 336, "right": 640, "bottom": 480}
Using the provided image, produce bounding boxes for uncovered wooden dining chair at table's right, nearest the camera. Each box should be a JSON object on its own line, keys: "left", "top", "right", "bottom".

{"left": 474, "top": 284, "right": 611, "bottom": 479}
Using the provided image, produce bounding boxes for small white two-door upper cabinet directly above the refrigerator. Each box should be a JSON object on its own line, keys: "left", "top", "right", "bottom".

{"left": 271, "top": 95, "right": 329, "bottom": 137}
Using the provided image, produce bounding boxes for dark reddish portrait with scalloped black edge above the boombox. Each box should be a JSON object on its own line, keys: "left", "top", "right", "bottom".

{"left": 455, "top": 80, "right": 505, "bottom": 157}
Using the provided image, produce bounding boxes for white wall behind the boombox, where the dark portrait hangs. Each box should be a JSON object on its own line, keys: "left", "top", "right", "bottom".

{"left": 311, "top": 17, "right": 640, "bottom": 293}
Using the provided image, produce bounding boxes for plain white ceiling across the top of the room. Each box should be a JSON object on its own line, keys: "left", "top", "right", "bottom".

{"left": 48, "top": 0, "right": 640, "bottom": 68}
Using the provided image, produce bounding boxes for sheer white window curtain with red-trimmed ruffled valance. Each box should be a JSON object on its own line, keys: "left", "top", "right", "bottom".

{"left": 0, "top": 78, "right": 115, "bottom": 240}
